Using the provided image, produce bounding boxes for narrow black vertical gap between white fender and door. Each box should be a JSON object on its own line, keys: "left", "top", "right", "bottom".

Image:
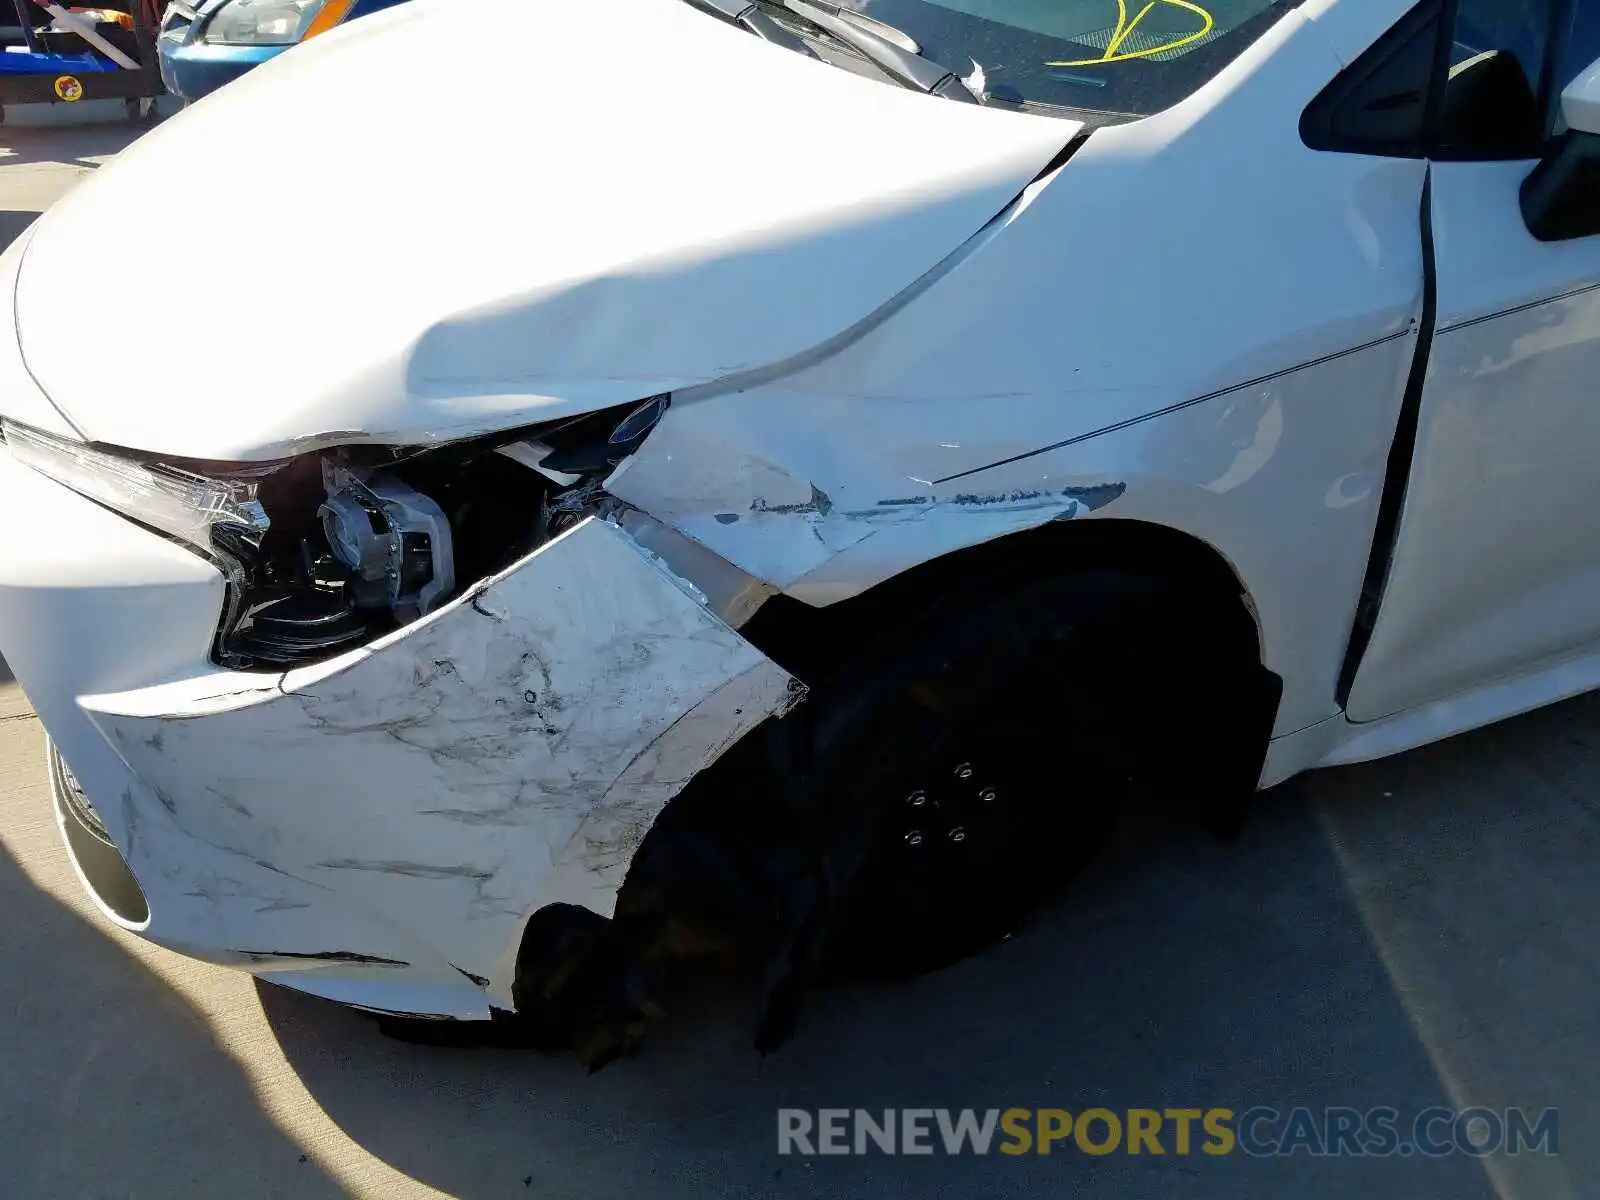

{"left": 1334, "top": 171, "right": 1438, "bottom": 709}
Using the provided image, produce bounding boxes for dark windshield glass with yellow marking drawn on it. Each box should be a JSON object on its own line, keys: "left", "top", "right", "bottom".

{"left": 755, "top": 0, "right": 1299, "bottom": 118}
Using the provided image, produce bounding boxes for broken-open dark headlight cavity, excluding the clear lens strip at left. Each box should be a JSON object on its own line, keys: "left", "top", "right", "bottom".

{"left": 213, "top": 397, "right": 667, "bottom": 669}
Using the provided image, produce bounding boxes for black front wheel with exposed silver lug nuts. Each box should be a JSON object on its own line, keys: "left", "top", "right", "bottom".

{"left": 787, "top": 574, "right": 1165, "bottom": 978}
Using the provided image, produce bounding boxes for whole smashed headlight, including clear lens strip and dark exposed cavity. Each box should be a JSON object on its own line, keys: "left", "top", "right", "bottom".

{"left": 0, "top": 395, "right": 669, "bottom": 670}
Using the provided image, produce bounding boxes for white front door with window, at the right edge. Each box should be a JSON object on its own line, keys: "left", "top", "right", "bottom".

{"left": 1346, "top": 0, "right": 1600, "bottom": 722}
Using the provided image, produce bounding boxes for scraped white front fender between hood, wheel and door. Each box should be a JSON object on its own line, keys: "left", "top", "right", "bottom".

{"left": 608, "top": 16, "right": 1424, "bottom": 733}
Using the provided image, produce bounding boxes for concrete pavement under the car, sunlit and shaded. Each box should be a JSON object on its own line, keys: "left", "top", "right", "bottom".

{"left": 0, "top": 126, "right": 1600, "bottom": 1200}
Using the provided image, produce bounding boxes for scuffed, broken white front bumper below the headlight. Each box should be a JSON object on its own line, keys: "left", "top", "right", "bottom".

{"left": 0, "top": 450, "right": 797, "bottom": 1018}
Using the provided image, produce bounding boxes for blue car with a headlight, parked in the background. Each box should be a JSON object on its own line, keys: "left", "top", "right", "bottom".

{"left": 157, "top": 0, "right": 402, "bottom": 101}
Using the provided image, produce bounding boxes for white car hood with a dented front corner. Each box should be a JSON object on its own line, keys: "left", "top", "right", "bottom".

{"left": 12, "top": 0, "right": 1078, "bottom": 459}
